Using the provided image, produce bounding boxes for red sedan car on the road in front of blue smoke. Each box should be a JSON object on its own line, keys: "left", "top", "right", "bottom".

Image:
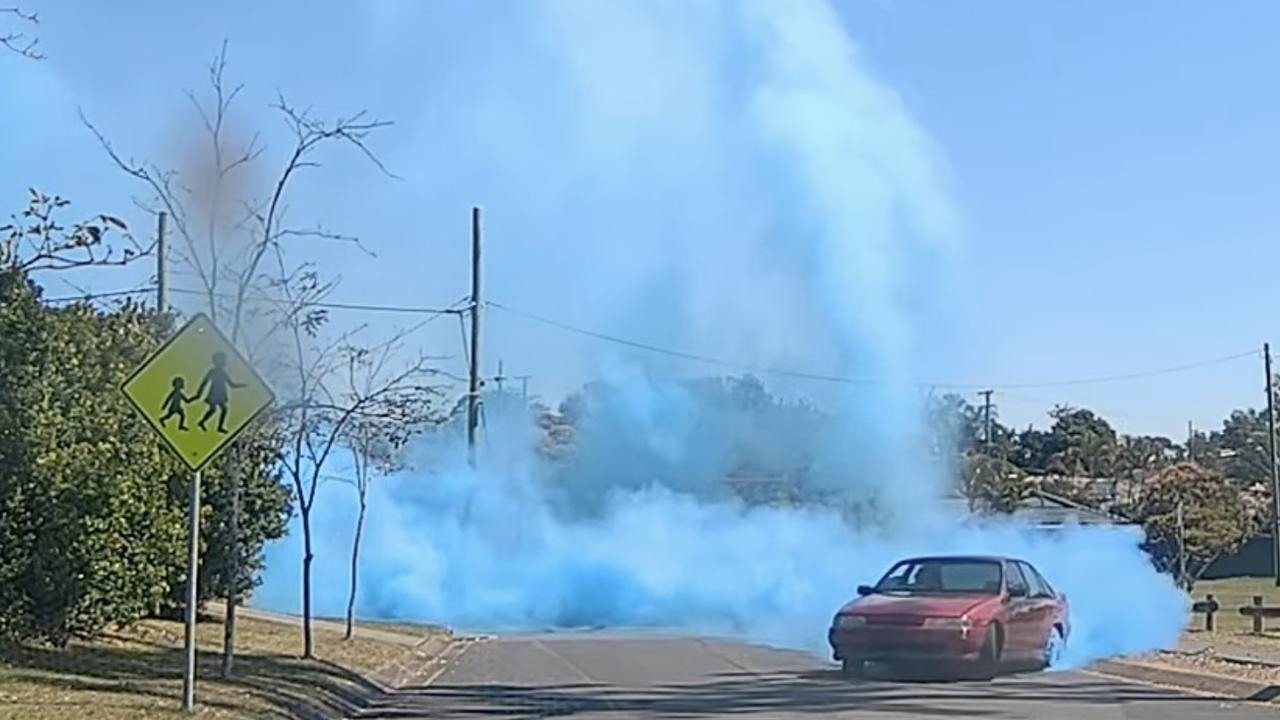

{"left": 827, "top": 556, "right": 1070, "bottom": 678}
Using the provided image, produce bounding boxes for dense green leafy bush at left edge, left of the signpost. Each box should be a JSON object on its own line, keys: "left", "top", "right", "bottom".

{"left": 0, "top": 269, "right": 186, "bottom": 644}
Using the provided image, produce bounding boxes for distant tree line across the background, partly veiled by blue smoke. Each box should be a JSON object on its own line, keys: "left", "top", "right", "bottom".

{"left": 538, "top": 375, "right": 1272, "bottom": 587}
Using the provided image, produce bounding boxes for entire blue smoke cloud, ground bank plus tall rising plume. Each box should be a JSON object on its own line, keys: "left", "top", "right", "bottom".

{"left": 255, "top": 0, "right": 1187, "bottom": 666}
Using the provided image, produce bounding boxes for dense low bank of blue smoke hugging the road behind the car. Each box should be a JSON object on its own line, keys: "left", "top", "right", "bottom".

{"left": 256, "top": 407, "right": 1187, "bottom": 666}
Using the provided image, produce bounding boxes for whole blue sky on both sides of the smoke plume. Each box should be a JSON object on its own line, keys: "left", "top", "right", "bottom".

{"left": 0, "top": 0, "right": 1280, "bottom": 437}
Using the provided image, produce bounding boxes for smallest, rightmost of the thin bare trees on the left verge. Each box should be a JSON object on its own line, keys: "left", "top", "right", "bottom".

{"left": 342, "top": 336, "right": 442, "bottom": 639}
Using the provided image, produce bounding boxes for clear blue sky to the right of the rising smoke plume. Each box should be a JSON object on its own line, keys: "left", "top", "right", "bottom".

{"left": 845, "top": 1, "right": 1280, "bottom": 437}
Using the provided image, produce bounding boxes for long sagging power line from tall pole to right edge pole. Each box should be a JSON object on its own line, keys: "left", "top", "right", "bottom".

{"left": 485, "top": 300, "right": 1258, "bottom": 389}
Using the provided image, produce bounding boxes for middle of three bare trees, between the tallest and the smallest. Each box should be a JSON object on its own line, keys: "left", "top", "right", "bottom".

{"left": 267, "top": 250, "right": 440, "bottom": 657}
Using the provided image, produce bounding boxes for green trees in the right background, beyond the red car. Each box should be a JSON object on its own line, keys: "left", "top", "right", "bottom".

{"left": 931, "top": 395, "right": 1274, "bottom": 588}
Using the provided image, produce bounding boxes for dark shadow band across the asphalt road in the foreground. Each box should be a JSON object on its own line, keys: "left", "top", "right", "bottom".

{"left": 360, "top": 670, "right": 1217, "bottom": 719}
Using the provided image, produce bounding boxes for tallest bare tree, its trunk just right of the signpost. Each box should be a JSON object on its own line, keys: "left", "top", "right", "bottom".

{"left": 82, "top": 42, "right": 394, "bottom": 676}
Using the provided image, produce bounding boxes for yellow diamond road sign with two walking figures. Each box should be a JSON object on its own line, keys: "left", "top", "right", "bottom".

{"left": 123, "top": 314, "right": 274, "bottom": 470}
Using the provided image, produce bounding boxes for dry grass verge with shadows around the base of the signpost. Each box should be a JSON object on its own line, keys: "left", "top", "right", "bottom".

{"left": 0, "top": 607, "right": 437, "bottom": 720}
